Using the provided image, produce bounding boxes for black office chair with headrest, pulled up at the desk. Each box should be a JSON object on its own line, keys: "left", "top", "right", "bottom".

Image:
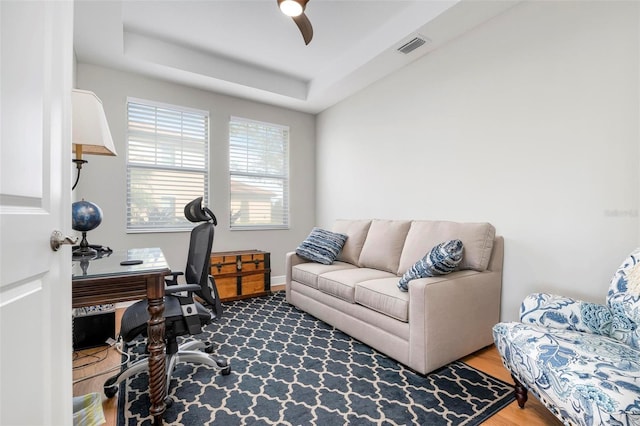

{"left": 104, "top": 197, "right": 231, "bottom": 404}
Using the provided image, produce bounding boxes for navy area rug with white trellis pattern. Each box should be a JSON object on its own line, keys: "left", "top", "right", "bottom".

{"left": 118, "top": 292, "right": 514, "bottom": 426}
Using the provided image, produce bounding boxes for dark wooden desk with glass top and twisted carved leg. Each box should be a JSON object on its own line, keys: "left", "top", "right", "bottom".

{"left": 72, "top": 248, "right": 171, "bottom": 424}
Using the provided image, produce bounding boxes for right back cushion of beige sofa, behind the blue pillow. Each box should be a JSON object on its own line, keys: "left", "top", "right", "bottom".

{"left": 397, "top": 220, "right": 496, "bottom": 275}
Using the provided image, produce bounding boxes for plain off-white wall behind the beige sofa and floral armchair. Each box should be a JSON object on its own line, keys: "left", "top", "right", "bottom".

{"left": 316, "top": 1, "right": 640, "bottom": 320}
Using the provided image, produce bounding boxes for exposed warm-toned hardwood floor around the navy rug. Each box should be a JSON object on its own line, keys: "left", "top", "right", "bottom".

{"left": 73, "top": 296, "right": 562, "bottom": 426}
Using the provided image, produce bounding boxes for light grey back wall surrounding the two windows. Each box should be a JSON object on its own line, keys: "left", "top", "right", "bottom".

{"left": 73, "top": 63, "right": 315, "bottom": 283}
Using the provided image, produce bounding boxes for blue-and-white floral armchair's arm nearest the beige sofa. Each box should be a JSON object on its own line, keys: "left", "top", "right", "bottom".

{"left": 520, "top": 293, "right": 612, "bottom": 336}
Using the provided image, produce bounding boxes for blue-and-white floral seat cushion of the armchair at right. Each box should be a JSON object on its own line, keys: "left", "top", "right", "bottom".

{"left": 493, "top": 322, "right": 640, "bottom": 425}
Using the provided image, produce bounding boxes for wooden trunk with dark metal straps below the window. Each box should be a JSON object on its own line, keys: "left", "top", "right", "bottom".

{"left": 211, "top": 250, "right": 271, "bottom": 301}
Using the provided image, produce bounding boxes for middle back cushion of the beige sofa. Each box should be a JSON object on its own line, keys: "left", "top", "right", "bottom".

{"left": 359, "top": 219, "right": 412, "bottom": 274}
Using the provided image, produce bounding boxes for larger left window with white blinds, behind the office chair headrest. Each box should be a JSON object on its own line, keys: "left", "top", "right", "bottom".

{"left": 127, "top": 98, "right": 209, "bottom": 232}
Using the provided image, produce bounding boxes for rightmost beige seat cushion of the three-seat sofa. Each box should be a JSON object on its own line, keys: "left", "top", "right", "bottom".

{"left": 355, "top": 277, "right": 409, "bottom": 322}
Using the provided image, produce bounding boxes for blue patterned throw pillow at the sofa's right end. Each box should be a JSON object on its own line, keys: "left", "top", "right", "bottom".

{"left": 398, "top": 240, "right": 464, "bottom": 291}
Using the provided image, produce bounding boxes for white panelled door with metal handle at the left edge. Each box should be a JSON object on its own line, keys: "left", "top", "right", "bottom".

{"left": 0, "top": 0, "right": 73, "bottom": 425}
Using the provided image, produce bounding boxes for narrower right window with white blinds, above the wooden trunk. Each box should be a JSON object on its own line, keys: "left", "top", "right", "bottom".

{"left": 229, "top": 117, "right": 289, "bottom": 229}
